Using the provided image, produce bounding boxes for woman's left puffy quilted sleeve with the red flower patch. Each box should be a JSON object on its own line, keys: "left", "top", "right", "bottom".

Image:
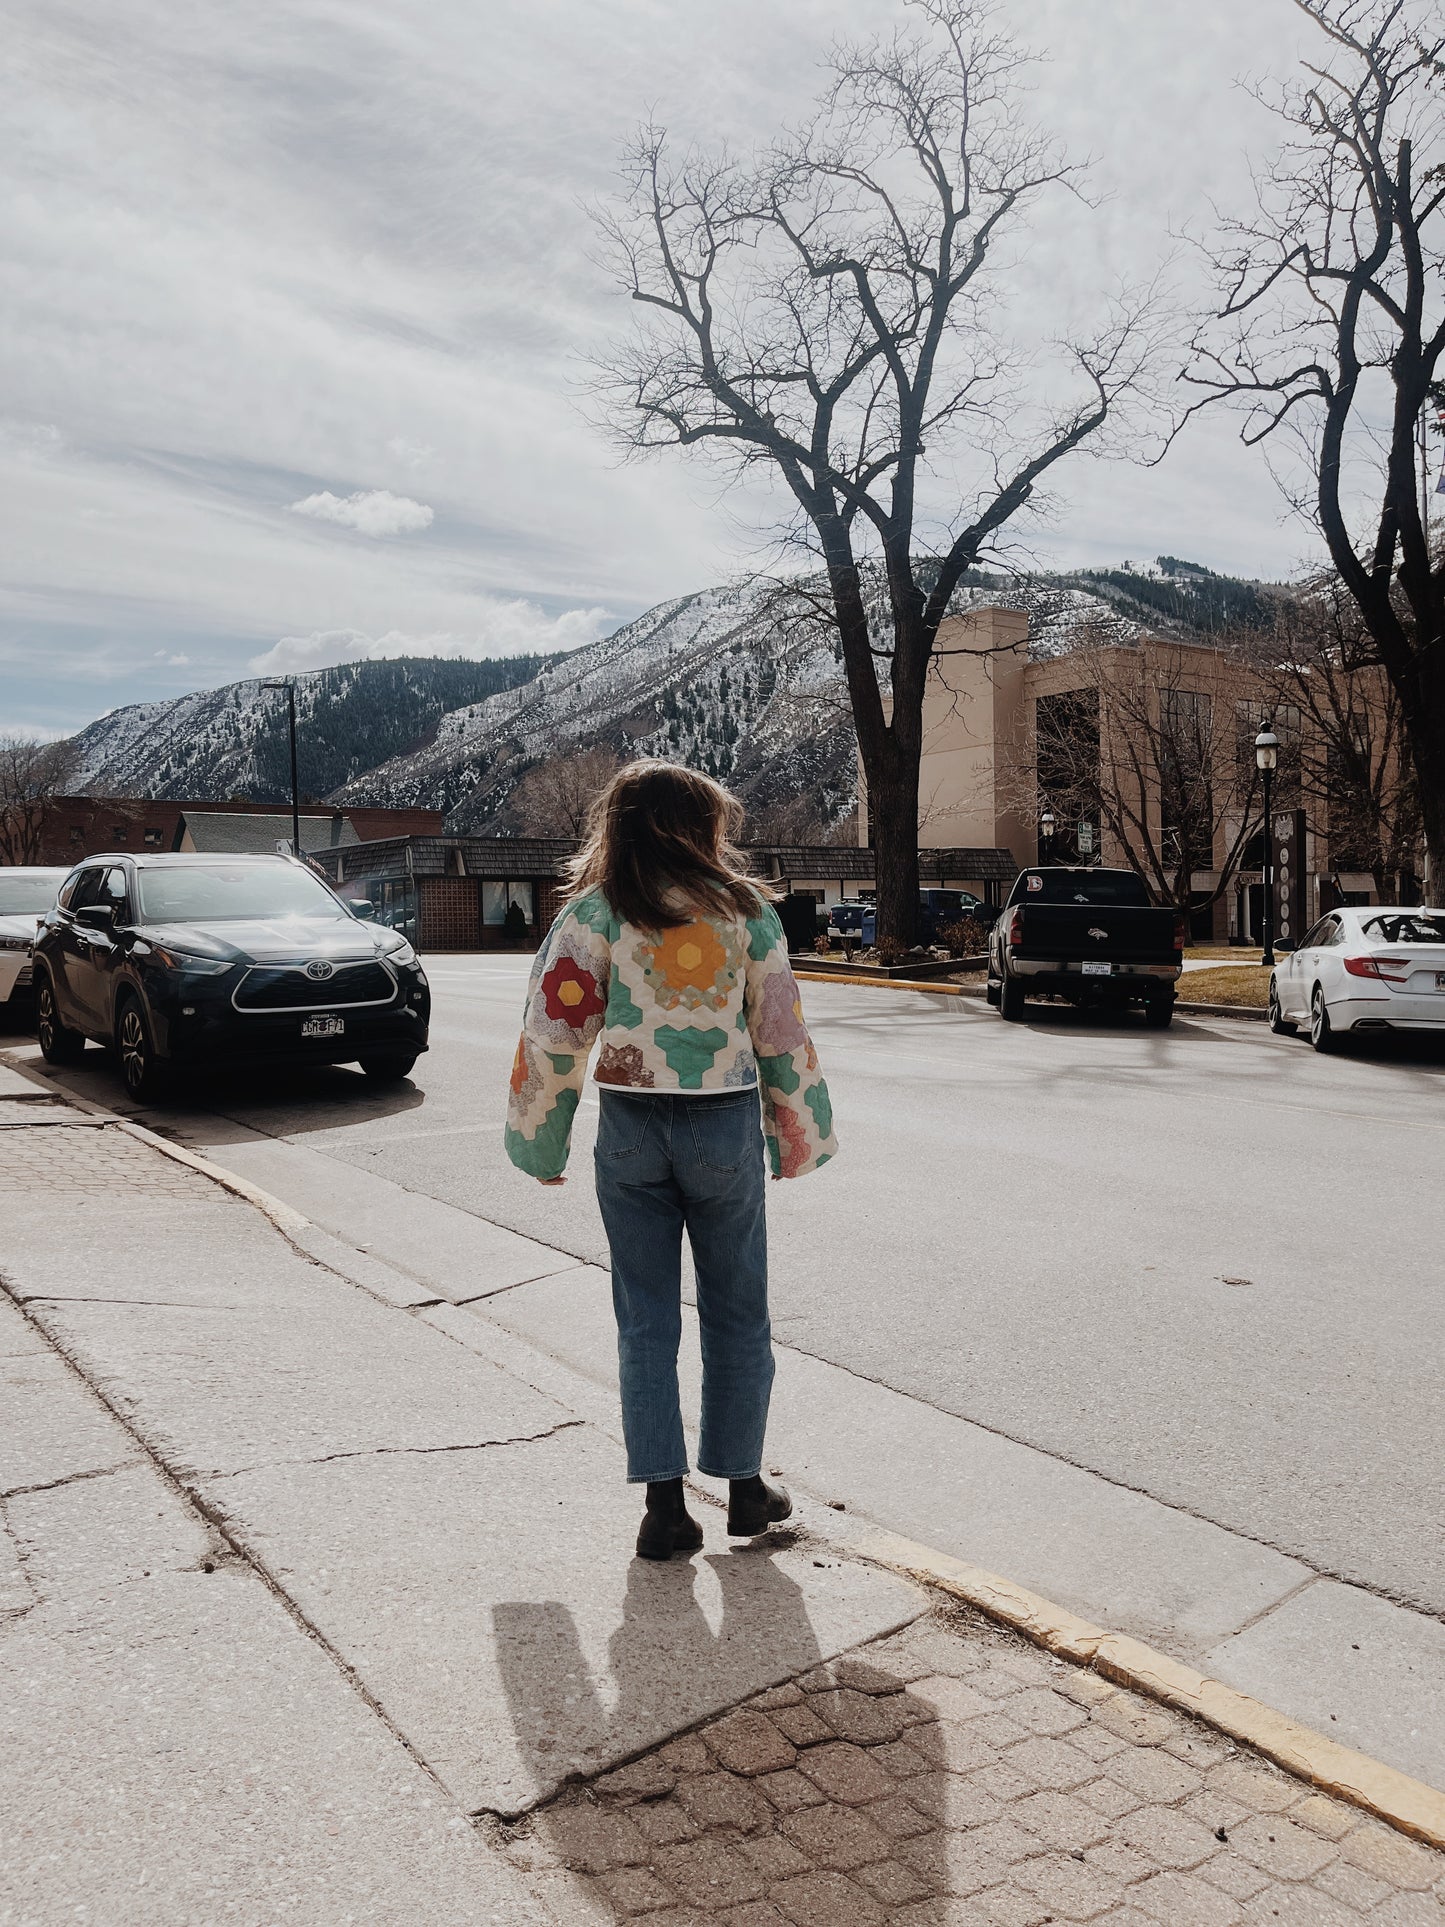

{"left": 505, "top": 908, "right": 613, "bottom": 1177}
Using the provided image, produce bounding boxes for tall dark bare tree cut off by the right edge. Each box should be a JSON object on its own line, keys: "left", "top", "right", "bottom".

{"left": 1187, "top": 0, "right": 1445, "bottom": 879}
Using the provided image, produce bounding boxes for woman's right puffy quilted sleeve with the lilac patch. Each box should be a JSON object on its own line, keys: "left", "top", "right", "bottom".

{"left": 746, "top": 904, "right": 838, "bottom": 1177}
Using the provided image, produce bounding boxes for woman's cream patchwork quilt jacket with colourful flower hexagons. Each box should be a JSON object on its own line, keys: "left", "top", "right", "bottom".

{"left": 507, "top": 890, "right": 838, "bottom": 1177}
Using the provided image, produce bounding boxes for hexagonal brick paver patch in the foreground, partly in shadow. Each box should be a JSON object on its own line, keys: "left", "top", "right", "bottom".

{"left": 501, "top": 1609, "right": 1445, "bottom": 1927}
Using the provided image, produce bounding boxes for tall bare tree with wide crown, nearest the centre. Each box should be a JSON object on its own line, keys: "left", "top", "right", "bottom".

{"left": 599, "top": 0, "right": 1154, "bottom": 940}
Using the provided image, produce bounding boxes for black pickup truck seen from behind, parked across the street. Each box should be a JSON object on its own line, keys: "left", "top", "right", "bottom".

{"left": 988, "top": 867, "right": 1185, "bottom": 1031}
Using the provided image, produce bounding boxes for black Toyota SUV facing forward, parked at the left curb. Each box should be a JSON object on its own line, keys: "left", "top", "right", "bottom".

{"left": 35, "top": 856, "right": 432, "bottom": 1098}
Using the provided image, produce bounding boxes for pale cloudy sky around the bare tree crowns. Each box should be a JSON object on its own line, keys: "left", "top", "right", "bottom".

{"left": 0, "top": 0, "right": 1333, "bottom": 732}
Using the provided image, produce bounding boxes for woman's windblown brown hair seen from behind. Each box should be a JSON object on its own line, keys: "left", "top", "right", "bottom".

{"left": 566, "top": 757, "right": 776, "bottom": 931}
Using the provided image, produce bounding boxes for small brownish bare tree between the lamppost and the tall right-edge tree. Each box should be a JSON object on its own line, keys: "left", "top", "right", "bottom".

{"left": 1237, "top": 574, "right": 1420, "bottom": 902}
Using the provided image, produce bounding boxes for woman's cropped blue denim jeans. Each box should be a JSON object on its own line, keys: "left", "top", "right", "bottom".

{"left": 595, "top": 1091, "right": 773, "bottom": 1486}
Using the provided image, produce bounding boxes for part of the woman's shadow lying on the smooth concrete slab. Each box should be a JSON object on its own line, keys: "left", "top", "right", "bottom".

{"left": 493, "top": 1540, "right": 821, "bottom": 1800}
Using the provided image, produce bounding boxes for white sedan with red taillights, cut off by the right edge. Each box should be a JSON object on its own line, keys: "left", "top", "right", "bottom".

{"left": 1270, "top": 904, "right": 1445, "bottom": 1050}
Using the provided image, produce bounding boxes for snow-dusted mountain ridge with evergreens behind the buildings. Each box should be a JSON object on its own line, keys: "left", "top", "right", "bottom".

{"left": 65, "top": 557, "right": 1268, "bottom": 834}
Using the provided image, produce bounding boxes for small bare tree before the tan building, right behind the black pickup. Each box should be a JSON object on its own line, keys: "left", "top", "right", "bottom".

{"left": 1027, "top": 630, "right": 1260, "bottom": 911}
